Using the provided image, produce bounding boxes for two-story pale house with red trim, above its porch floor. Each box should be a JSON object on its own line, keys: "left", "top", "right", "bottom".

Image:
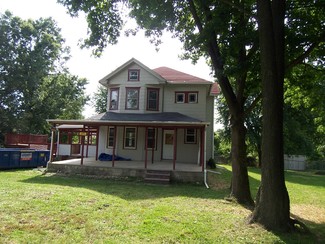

{"left": 48, "top": 58, "right": 219, "bottom": 173}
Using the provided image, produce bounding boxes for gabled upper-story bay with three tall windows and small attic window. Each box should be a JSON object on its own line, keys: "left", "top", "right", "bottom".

{"left": 99, "top": 58, "right": 166, "bottom": 113}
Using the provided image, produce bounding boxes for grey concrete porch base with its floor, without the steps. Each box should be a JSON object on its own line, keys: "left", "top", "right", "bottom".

{"left": 47, "top": 158, "right": 204, "bottom": 183}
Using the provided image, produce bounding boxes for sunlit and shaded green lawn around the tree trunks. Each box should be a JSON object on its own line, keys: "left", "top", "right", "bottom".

{"left": 0, "top": 167, "right": 325, "bottom": 243}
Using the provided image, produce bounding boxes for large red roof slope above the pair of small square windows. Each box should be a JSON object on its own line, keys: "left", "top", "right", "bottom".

{"left": 153, "top": 67, "right": 211, "bottom": 84}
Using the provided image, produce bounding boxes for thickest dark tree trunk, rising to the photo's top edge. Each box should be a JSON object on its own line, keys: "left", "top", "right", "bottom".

{"left": 251, "top": 0, "right": 290, "bottom": 231}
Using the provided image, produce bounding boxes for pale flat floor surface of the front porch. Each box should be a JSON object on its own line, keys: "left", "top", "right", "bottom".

{"left": 51, "top": 158, "right": 202, "bottom": 172}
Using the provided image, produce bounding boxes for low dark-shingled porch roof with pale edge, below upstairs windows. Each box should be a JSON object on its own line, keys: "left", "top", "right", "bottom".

{"left": 47, "top": 112, "right": 210, "bottom": 126}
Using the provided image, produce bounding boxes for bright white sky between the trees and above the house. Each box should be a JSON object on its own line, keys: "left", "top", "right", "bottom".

{"left": 0, "top": 0, "right": 213, "bottom": 117}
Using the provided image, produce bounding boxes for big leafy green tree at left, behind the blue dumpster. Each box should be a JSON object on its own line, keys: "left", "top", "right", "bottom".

{"left": 0, "top": 11, "right": 87, "bottom": 144}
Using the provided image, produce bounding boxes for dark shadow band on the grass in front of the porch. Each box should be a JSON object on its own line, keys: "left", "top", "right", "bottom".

{"left": 21, "top": 170, "right": 229, "bottom": 201}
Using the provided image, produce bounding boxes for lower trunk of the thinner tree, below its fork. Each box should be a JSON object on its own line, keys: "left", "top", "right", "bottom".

{"left": 230, "top": 114, "right": 254, "bottom": 206}
